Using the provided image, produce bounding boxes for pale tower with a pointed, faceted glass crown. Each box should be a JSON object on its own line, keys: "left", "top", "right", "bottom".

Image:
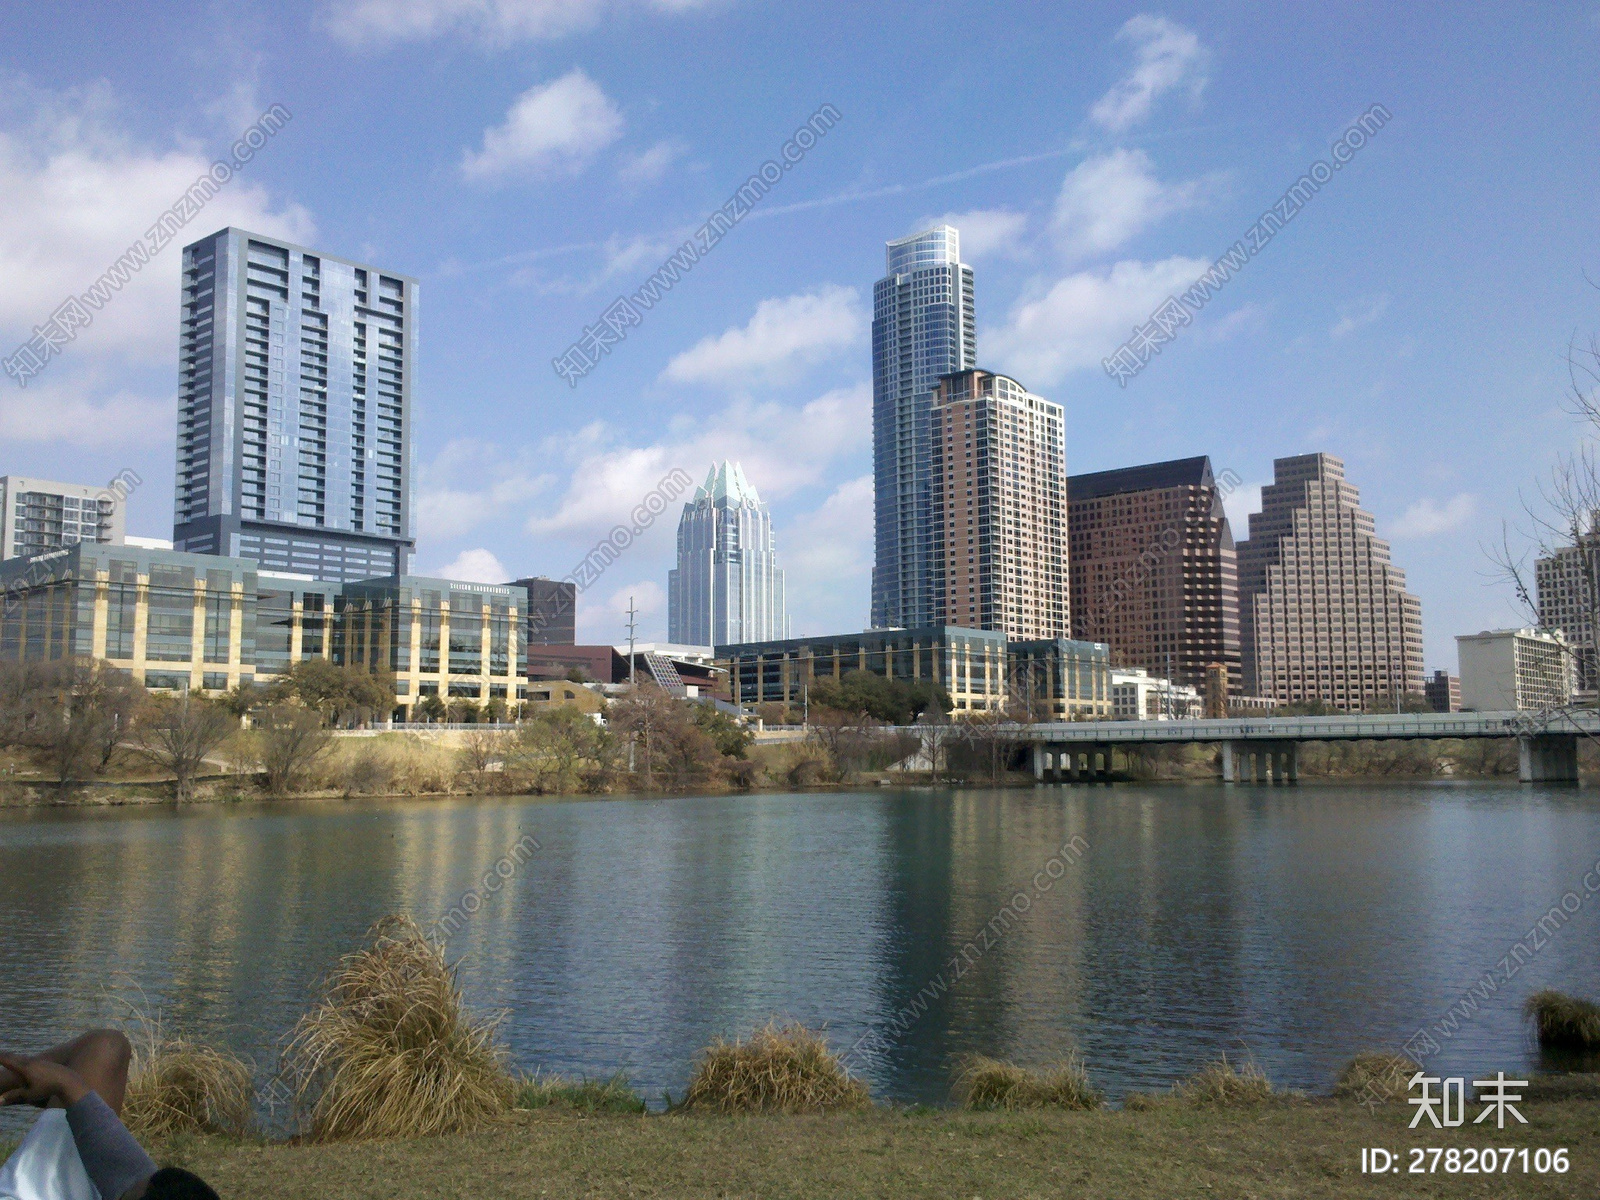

{"left": 667, "top": 462, "right": 789, "bottom": 646}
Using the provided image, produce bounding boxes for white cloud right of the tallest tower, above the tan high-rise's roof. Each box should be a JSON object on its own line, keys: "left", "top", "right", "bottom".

{"left": 979, "top": 258, "right": 1211, "bottom": 389}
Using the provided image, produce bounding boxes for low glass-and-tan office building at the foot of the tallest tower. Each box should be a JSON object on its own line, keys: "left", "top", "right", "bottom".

{"left": 717, "top": 626, "right": 1006, "bottom": 712}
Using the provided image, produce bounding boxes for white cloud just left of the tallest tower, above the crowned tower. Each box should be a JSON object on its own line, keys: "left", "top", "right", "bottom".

{"left": 661, "top": 285, "right": 867, "bottom": 387}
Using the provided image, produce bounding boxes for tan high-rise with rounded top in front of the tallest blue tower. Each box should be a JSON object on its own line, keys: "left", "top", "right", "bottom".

{"left": 930, "top": 370, "right": 1072, "bottom": 642}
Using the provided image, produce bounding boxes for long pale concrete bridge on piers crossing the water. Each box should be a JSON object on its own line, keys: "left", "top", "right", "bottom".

{"left": 998, "top": 709, "right": 1600, "bottom": 782}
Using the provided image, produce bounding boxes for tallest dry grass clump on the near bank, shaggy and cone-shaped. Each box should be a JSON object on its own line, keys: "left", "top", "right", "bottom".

{"left": 283, "top": 917, "right": 514, "bottom": 1141}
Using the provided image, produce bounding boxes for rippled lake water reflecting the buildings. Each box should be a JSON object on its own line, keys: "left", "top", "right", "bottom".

{"left": 0, "top": 784, "right": 1600, "bottom": 1101}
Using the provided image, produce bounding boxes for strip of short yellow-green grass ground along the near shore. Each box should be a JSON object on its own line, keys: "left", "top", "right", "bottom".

{"left": 158, "top": 1099, "right": 1600, "bottom": 1200}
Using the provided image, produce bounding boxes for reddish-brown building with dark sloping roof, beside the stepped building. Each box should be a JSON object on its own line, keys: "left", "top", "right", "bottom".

{"left": 1067, "top": 456, "right": 1240, "bottom": 691}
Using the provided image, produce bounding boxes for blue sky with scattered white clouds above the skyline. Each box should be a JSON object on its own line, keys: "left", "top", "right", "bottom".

{"left": 0, "top": 0, "right": 1600, "bottom": 669}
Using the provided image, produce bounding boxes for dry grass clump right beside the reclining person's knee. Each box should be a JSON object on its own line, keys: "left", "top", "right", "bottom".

{"left": 122, "top": 1026, "right": 253, "bottom": 1138}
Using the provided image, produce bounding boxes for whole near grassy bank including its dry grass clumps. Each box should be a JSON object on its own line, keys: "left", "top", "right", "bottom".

{"left": 65, "top": 917, "right": 1600, "bottom": 1198}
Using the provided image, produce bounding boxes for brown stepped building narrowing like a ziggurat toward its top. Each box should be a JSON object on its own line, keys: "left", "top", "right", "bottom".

{"left": 1238, "top": 454, "right": 1422, "bottom": 710}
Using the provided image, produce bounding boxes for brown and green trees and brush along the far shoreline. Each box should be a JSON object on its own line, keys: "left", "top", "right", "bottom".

{"left": 0, "top": 659, "right": 1600, "bottom": 806}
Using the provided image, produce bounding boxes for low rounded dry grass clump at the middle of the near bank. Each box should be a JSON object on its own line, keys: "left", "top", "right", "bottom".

{"left": 682, "top": 1022, "right": 870, "bottom": 1112}
